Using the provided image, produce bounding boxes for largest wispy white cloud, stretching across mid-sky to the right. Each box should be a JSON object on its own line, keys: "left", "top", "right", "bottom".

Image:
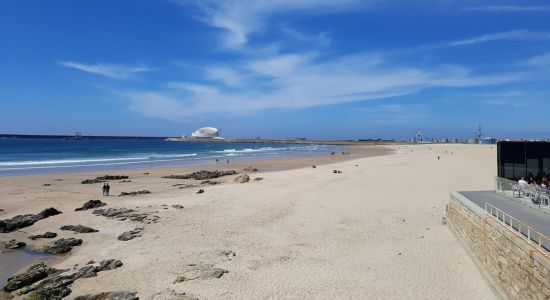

{"left": 117, "top": 53, "right": 541, "bottom": 120}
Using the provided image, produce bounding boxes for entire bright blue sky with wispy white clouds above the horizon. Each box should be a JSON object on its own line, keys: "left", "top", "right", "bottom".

{"left": 0, "top": 0, "right": 550, "bottom": 139}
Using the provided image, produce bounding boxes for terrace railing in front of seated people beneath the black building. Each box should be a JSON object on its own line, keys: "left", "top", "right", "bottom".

{"left": 495, "top": 177, "right": 550, "bottom": 211}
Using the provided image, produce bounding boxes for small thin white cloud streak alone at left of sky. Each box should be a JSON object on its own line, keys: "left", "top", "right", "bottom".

{"left": 59, "top": 61, "right": 152, "bottom": 79}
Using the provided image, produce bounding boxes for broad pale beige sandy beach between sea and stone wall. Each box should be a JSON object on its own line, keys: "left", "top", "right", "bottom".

{"left": 0, "top": 145, "right": 496, "bottom": 299}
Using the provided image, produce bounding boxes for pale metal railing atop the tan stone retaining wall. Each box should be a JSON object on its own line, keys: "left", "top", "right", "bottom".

{"left": 485, "top": 202, "right": 550, "bottom": 252}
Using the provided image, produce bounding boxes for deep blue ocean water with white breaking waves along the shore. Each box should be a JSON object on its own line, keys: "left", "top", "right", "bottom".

{"left": 0, "top": 139, "right": 342, "bottom": 176}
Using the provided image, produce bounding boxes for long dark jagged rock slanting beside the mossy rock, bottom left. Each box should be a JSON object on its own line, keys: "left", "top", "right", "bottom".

{"left": 15, "top": 259, "right": 122, "bottom": 299}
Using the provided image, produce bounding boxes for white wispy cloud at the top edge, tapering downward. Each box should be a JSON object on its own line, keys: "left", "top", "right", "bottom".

{"left": 174, "top": 0, "right": 368, "bottom": 49}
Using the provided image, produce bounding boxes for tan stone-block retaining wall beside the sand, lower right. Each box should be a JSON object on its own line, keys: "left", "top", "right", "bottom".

{"left": 447, "top": 193, "right": 550, "bottom": 299}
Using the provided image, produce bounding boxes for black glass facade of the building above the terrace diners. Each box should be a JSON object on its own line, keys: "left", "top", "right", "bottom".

{"left": 497, "top": 142, "right": 550, "bottom": 180}
